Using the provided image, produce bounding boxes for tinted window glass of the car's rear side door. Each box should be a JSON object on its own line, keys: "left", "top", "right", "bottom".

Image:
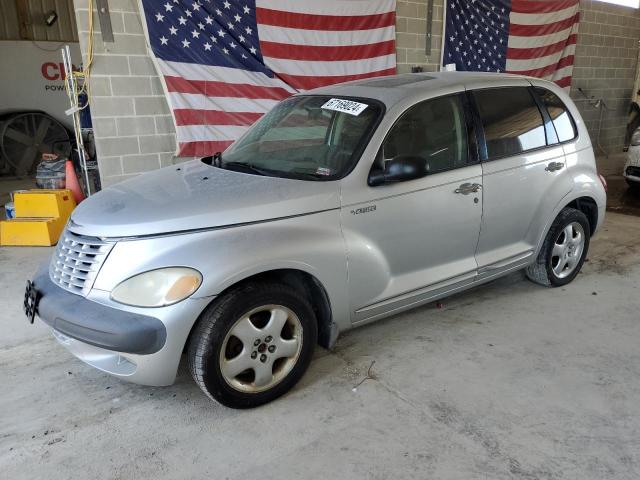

{"left": 473, "top": 87, "right": 547, "bottom": 160}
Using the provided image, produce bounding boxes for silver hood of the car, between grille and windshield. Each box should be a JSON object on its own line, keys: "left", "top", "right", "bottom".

{"left": 70, "top": 160, "right": 339, "bottom": 237}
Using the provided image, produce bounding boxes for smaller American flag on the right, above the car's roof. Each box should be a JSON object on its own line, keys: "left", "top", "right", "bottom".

{"left": 442, "top": 0, "right": 579, "bottom": 87}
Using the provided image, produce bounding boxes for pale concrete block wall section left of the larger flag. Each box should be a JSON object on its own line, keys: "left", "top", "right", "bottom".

{"left": 74, "top": 0, "right": 177, "bottom": 187}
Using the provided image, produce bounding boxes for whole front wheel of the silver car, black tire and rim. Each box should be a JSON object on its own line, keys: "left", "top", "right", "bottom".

{"left": 187, "top": 283, "right": 318, "bottom": 408}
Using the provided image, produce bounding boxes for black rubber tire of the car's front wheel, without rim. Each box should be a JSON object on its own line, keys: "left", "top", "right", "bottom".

{"left": 192, "top": 284, "right": 318, "bottom": 408}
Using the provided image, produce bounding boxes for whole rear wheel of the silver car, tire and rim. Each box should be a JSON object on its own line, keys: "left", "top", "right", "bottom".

{"left": 525, "top": 208, "right": 591, "bottom": 287}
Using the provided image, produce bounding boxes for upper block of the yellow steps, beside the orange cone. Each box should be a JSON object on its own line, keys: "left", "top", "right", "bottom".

{"left": 13, "top": 190, "right": 76, "bottom": 222}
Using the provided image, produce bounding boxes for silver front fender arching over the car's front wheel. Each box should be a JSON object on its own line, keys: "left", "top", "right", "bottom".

{"left": 93, "top": 210, "right": 351, "bottom": 330}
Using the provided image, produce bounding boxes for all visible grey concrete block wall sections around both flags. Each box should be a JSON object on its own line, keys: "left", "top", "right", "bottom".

{"left": 74, "top": 0, "right": 640, "bottom": 186}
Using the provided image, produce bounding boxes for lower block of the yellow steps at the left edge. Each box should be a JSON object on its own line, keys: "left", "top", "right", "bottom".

{"left": 0, "top": 217, "right": 67, "bottom": 247}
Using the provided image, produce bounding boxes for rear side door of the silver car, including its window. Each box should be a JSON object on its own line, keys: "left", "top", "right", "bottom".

{"left": 472, "top": 85, "right": 571, "bottom": 278}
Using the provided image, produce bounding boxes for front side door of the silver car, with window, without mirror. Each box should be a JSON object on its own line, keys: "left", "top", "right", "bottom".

{"left": 341, "top": 94, "right": 482, "bottom": 324}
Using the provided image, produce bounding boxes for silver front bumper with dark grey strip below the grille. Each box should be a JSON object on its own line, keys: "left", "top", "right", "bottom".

{"left": 33, "top": 267, "right": 212, "bottom": 386}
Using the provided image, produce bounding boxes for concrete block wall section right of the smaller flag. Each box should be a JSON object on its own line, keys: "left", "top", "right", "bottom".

{"left": 571, "top": 0, "right": 640, "bottom": 154}
